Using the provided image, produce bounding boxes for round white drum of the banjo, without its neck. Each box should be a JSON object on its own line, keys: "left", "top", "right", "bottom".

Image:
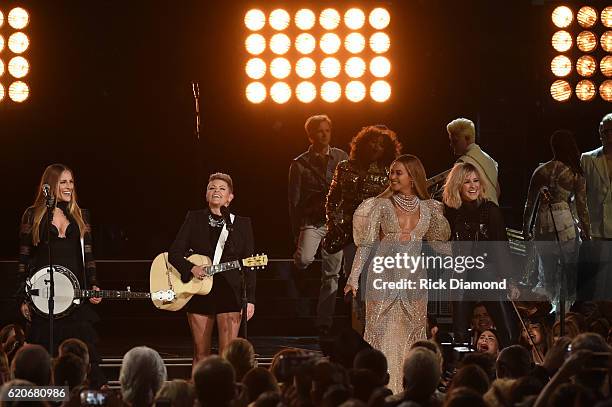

{"left": 30, "top": 266, "right": 79, "bottom": 317}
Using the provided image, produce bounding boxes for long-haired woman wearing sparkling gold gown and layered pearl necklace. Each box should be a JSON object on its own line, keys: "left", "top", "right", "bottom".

{"left": 344, "top": 154, "right": 450, "bottom": 393}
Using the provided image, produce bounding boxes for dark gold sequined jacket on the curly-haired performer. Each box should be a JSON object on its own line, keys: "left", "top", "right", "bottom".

{"left": 325, "top": 160, "right": 389, "bottom": 246}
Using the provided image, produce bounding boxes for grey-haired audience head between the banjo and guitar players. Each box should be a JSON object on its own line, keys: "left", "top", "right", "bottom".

{"left": 119, "top": 346, "right": 167, "bottom": 406}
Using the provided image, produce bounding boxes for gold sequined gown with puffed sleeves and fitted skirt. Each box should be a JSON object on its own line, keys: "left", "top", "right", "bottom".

{"left": 348, "top": 198, "right": 450, "bottom": 393}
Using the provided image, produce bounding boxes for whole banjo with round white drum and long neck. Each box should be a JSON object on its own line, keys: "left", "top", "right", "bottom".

{"left": 26, "top": 265, "right": 175, "bottom": 318}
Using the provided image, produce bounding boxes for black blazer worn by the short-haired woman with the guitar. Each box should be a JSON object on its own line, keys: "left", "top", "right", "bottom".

{"left": 168, "top": 209, "right": 256, "bottom": 303}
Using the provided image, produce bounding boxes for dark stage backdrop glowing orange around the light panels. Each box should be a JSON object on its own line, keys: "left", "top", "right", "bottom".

{"left": 0, "top": 0, "right": 610, "bottom": 260}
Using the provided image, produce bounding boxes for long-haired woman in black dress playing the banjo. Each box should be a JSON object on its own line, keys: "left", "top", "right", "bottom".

{"left": 18, "top": 164, "right": 101, "bottom": 382}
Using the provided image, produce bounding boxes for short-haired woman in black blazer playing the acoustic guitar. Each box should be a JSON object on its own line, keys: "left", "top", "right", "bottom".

{"left": 168, "top": 173, "right": 255, "bottom": 366}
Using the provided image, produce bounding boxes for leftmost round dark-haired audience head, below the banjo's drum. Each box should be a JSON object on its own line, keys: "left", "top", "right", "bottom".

{"left": 11, "top": 344, "right": 51, "bottom": 386}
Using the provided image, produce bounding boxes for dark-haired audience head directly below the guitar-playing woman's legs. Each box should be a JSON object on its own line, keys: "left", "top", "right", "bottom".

{"left": 193, "top": 355, "right": 236, "bottom": 407}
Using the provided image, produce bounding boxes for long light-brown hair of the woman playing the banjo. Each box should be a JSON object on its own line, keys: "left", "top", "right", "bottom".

{"left": 31, "top": 164, "right": 85, "bottom": 246}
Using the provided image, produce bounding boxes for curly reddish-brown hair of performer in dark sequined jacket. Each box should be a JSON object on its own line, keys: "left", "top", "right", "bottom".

{"left": 349, "top": 125, "right": 402, "bottom": 167}
